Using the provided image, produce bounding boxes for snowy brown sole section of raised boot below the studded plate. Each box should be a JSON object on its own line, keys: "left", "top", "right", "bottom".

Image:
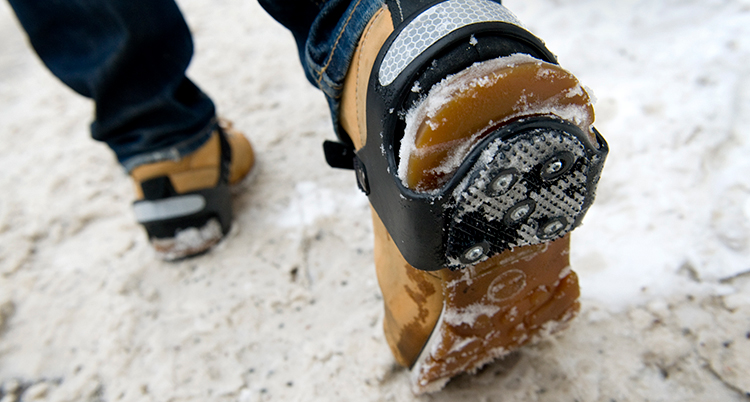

{"left": 411, "top": 236, "right": 579, "bottom": 394}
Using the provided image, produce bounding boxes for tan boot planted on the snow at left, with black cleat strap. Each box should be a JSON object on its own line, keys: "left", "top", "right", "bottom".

{"left": 130, "top": 121, "right": 255, "bottom": 261}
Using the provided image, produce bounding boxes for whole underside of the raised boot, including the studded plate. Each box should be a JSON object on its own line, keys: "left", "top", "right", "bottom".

{"left": 402, "top": 57, "right": 606, "bottom": 394}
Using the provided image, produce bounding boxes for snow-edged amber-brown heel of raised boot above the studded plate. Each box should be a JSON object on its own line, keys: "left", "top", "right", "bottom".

{"left": 405, "top": 58, "right": 596, "bottom": 190}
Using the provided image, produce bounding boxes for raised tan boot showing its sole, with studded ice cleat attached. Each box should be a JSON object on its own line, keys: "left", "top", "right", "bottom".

{"left": 341, "top": 0, "right": 607, "bottom": 393}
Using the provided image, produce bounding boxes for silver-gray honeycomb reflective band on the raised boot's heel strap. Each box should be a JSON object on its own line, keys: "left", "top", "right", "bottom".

{"left": 378, "top": 0, "right": 521, "bottom": 86}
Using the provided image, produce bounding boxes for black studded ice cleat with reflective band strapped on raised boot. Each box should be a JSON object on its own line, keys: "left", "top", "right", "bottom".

{"left": 327, "top": 0, "right": 608, "bottom": 271}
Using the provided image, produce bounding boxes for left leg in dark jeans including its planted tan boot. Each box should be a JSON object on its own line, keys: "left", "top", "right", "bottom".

{"left": 10, "top": 0, "right": 254, "bottom": 260}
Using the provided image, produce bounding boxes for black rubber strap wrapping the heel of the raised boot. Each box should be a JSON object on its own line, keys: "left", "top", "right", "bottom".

{"left": 357, "top": 8, "right": 580, "bottom": 271}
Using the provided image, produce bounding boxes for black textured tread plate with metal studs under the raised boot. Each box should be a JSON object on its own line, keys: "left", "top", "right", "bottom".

{"left": 446, "top": 124, "right": 602, "bottom": 269}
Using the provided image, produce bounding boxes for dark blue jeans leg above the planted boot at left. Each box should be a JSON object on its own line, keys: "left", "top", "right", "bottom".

{"left": 9, "top": 0, "right": 216, "bottom": 170}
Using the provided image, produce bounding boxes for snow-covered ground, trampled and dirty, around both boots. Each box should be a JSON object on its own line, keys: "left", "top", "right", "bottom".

{"left": 0, "top": 0, "right": 750, "bottom": 402}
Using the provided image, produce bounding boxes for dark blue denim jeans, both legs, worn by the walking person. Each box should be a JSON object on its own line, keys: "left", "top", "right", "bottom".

{"left": 9, "top": 0, "right": 384, "bottom": 170}
